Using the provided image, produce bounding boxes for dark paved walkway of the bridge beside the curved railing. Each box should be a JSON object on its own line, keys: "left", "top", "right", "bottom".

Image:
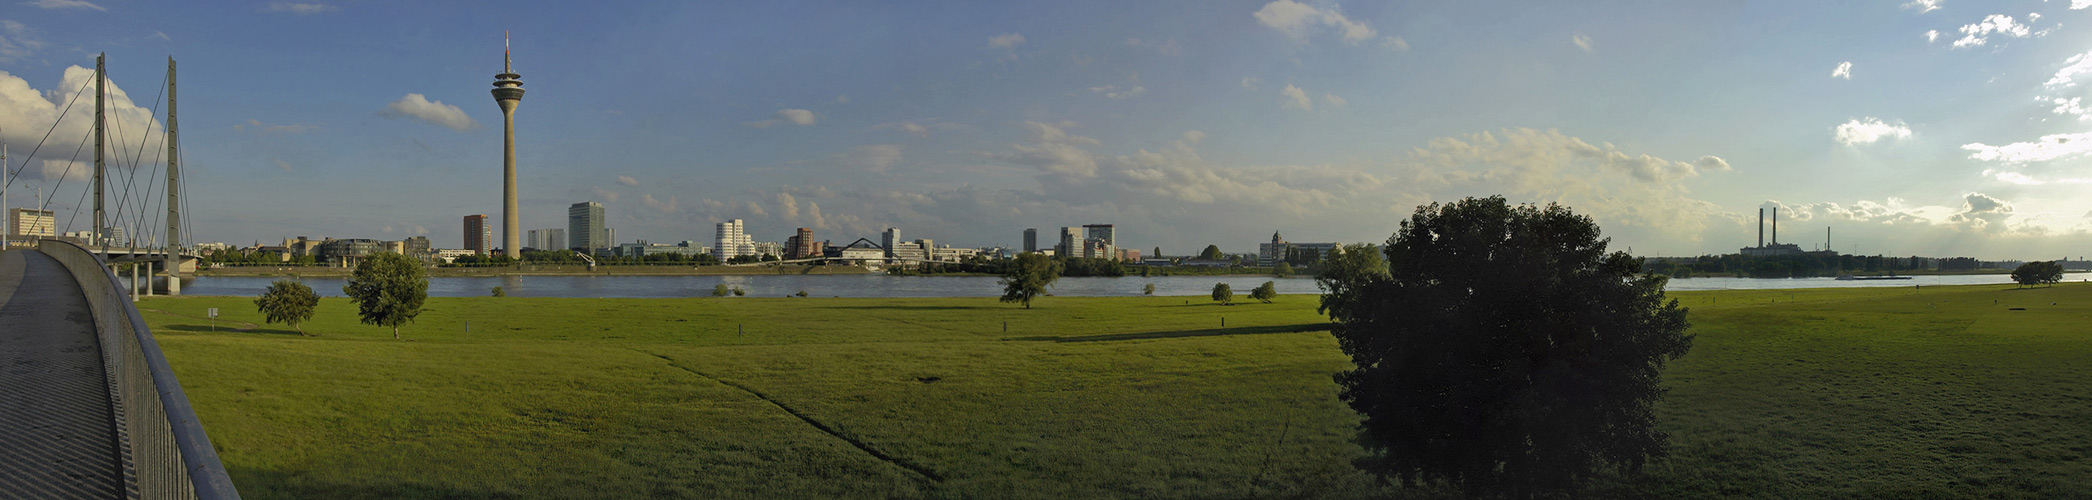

{"left": 0, "top": 249, "right": 123, "bottom": 498}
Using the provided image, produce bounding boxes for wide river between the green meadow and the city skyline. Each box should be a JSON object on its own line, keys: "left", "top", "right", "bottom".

{"left": 167, "top": 272, "right": 2092, "bottom": 299}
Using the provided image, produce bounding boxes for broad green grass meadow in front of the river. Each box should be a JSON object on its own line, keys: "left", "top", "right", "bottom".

{"left": 140, "top": 285, "right": 2092, "bottom": 498}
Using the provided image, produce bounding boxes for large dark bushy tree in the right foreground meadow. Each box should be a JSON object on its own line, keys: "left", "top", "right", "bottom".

{"left": 1318, "top": 197, "right": 1692, "bottom": 496}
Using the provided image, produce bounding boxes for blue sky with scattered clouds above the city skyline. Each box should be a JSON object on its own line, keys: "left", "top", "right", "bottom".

{"left": 0, "top": 0, "right": 2092, "bottom": 259}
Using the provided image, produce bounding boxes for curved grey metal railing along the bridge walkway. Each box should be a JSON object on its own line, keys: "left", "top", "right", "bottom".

{"left": 38, "top": 241, "right": 241, "bottom": 500}
